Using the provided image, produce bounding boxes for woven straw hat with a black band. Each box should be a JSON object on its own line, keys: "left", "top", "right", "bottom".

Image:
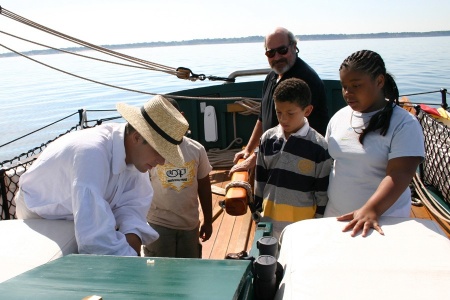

{"left": 116, "top": 95, "right": 189, "bottom": 166}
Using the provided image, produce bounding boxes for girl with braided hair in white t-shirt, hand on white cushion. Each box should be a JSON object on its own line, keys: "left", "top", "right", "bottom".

{"left": 325, "top": 50, "right": 425, "bottom": 236}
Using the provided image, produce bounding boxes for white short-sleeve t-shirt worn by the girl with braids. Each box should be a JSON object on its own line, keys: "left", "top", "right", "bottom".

{"left": 324, "top": 106, "right": 425, "bottom": 217}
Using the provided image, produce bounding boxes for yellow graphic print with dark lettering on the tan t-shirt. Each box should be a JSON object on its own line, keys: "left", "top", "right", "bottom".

{"left": 157, "top": 160, "right": 195, "bottom": 192}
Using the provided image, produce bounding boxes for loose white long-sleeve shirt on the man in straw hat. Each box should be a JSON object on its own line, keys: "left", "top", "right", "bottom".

{"left": 19, "top": 124, "right": 158, "bottom": 256}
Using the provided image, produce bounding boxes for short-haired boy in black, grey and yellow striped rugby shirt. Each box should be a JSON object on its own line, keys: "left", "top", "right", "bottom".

{"left": 255, "top": 78, "right": 332, "bottom": 238}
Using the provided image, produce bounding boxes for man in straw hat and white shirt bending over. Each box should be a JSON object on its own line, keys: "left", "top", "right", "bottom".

{"left": 16, "top": 96, "right": 188, "bottom": 256}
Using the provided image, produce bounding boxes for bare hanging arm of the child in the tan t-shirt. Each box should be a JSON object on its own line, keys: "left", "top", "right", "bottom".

{"left": 198, "top": 174, "right": 212, "bottom": 242}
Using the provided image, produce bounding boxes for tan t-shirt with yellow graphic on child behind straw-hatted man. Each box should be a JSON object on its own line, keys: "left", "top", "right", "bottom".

{"left": 147, "top": 137, "right": 212, "bottom": 230}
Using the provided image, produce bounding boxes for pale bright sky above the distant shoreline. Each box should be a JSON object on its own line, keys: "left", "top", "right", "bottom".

{"left": 0, "top": 0, "right": 450, "bottom": 53}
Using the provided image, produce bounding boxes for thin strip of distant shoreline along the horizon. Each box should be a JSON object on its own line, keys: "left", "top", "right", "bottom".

{"left": 0, "top": 31, "right": 450, "bottom": 58}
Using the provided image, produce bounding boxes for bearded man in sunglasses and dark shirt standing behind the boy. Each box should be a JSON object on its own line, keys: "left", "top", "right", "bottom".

{"left": 230, "top": 27, "right": 329, "bottom": 176}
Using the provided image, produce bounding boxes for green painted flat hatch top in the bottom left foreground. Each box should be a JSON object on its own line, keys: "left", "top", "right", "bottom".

{"left": 0, "top": 254, "right": 251, "bottom": 300}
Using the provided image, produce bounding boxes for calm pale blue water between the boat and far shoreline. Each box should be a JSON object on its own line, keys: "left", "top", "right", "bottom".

{"left": 0, "top": 37, "right": 450, "bottom": 161}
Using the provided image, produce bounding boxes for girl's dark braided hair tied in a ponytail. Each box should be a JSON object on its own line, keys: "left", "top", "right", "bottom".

{"left": 339, "top": 50, "right": 399, "bottom": 144}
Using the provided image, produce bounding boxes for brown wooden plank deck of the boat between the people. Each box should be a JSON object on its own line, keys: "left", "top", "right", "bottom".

{"left": 200, "top": 169, "right": 450, "bottom": 259}
